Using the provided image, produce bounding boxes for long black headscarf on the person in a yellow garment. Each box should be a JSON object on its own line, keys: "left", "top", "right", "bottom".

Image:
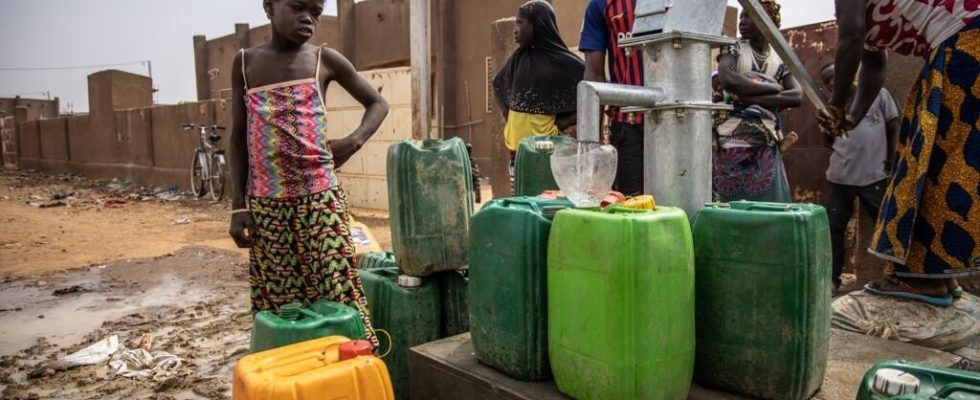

{"left": 493, "top": 0, "right": 585, "bottom": 115}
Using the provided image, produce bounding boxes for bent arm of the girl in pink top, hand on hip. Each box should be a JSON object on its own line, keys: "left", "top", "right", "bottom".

{"left": 321, "top": 48, "right": 388, "bottom": 168}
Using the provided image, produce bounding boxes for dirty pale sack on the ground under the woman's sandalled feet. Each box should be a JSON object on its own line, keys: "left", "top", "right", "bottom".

{"left": 831, "top": 292, "right": 980, "bottom": 351}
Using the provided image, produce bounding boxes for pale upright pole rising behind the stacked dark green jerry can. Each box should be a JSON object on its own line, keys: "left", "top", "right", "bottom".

{"left": 409, "top": 0, "right": 432, "bottom": 139}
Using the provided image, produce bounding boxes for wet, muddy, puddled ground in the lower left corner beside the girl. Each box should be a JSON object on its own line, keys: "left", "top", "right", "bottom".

{"left": 0, "top": 248, "right": 252, "bottom": 399}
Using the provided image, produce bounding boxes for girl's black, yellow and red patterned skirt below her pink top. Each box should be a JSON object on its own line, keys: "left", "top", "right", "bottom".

{"left": 249, "top": 186, "right": 377, "bottom": 347}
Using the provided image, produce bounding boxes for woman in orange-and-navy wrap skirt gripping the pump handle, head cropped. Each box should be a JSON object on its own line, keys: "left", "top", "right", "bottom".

{"left": 818, "top": 0, "right": 980, "bottom": 306}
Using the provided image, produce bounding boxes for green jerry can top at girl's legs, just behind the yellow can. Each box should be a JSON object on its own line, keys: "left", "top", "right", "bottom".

{"left": 251, "top": 300, "right": 365, "bottom": 353}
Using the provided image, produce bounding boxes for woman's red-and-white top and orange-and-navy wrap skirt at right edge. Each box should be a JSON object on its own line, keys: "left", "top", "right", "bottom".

{"left": 865, "top": 0, "right": 980, "bottom": 278}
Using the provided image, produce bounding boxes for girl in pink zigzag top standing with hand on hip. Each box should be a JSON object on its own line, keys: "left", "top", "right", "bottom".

{"left": 229, "top": 0, "right": 388, "bottom": 346}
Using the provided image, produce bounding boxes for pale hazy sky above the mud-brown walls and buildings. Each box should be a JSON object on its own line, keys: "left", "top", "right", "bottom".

{"left": 0, "top": 0, "right": 834, "bottom": 112}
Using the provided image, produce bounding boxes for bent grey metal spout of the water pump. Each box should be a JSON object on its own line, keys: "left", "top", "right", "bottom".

{"left": 576, "top": 81, "right": 665, "bottom": 142}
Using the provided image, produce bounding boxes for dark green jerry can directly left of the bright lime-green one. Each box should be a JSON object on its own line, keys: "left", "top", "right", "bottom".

{"left": 470, "top": 197, "right": 572, "bottom": 381}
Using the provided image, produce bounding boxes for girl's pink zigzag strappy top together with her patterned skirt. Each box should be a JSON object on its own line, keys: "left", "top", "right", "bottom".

{"left": 242, "top": 49, "right": 377, "bottom": 346}
